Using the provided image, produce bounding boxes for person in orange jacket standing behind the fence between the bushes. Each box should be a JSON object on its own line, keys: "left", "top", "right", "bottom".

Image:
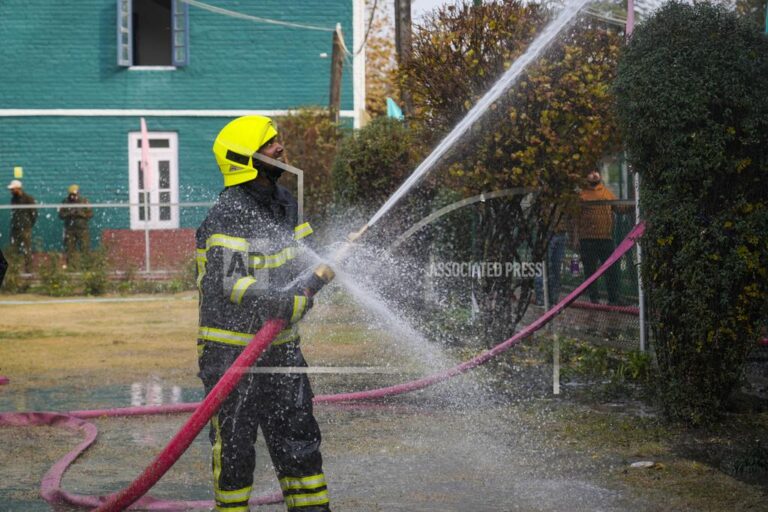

{"left": 573, "top": 170, "right": 619, "bottom": 304}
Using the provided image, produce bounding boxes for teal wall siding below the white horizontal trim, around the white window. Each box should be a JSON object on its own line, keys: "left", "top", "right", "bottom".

{"left": 0, "top": 117, "right": 229, "bottom": 249}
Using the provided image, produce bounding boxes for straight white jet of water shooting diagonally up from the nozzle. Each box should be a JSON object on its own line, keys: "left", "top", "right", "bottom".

{"left": 366, "top": 0, "right": 590, "bottom": 227}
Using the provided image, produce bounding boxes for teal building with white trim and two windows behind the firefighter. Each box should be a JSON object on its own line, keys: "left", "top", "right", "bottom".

{"left": 0, "top": 0, "right": 365, "bottom": 264}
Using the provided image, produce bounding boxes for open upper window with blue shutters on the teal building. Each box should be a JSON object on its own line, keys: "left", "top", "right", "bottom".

{"left": 117, "top": 0, "right": 189, "bottom": 67}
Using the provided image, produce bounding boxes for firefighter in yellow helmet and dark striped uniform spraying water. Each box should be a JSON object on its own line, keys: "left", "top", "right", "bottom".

{"left": 196, "top": 116, "right": 332, "bottom": 512}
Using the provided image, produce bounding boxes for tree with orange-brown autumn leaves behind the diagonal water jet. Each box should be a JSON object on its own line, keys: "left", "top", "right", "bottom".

{"left": 401, "top": 1, "right": 620, "bottom": 342}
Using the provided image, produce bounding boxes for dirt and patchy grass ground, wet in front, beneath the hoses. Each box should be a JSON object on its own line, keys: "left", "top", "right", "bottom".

{"left": 0, "top": 293, "right": 768, "bottom": 511}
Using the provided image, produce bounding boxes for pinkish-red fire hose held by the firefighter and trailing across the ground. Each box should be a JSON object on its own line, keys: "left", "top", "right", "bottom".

{"left": 0, "top": 224, "right": 645, "bottom": 512}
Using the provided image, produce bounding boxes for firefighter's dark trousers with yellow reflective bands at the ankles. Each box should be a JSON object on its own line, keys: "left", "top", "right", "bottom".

{"left": 199, "top": 340, "right": 330, "bottom": 512}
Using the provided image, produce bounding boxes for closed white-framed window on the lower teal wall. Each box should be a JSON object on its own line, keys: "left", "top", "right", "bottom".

{"left": 128, "top": 132, "right": 179, "bottom": 229}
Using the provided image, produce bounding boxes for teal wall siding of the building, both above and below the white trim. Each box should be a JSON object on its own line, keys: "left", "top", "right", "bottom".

{"left": 0, "top": 0, "right": 353, "bottom": 250}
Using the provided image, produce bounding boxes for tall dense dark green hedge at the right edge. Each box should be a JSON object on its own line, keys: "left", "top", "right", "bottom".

{"left": 616, "top": 2, "right": 768, "bottom": 423}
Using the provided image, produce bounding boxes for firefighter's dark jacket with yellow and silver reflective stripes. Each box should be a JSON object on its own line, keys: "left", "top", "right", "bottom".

{"left": 196, "top": 182, "right": 312, "bottom": 349}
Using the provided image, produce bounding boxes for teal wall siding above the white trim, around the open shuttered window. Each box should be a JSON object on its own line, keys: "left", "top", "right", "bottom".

{"left": 0, "top": 0, "right": 353, "bottom": 110}
